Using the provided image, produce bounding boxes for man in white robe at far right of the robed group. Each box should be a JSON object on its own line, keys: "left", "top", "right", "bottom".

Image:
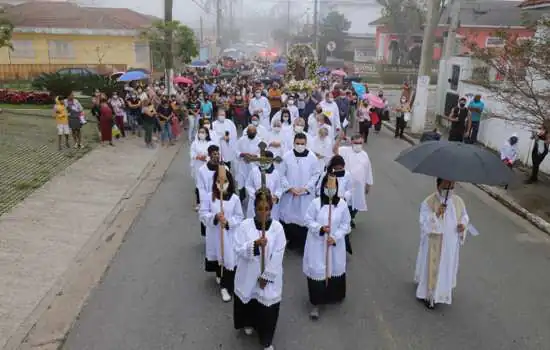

{"left": 335, "top": 134, "right": 374, "bottom": 228}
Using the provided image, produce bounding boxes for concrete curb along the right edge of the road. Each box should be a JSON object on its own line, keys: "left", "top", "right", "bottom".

{"left": 382, "top": 121, "right": 550, "bottom": 235}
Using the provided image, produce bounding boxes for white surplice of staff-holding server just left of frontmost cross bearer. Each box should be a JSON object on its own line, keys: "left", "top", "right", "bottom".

{"left": 199, "top": 193, "right": 244, "bottom": 271}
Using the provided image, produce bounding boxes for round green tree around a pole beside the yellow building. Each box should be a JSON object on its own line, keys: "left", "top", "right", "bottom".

{"left": 144, "top": 21, "right": 199, "bottom": 69}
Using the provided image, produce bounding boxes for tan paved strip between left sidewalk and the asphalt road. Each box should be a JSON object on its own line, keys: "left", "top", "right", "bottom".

{"left": 2, "top": 142, "right": 185, "bottom": 350}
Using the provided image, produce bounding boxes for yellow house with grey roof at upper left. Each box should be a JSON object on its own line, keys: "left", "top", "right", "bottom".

{"left": 0, "top": 2, "right": 155, "bottom": 81}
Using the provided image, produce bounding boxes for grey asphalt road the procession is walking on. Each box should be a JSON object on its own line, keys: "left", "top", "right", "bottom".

{"left": 61, "top": 129, "right": 550, "bottom": 350}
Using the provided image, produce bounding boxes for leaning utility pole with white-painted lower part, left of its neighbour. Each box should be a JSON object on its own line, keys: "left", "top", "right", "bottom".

{"left": 411, "top": 0, "right": 441, "bottom": 134}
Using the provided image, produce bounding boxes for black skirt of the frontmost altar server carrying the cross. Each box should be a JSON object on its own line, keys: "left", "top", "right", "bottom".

{"left": 233, "top": 296, "right": 281, "bottom": 348}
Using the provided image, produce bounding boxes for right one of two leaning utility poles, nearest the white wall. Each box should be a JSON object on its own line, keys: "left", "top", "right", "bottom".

{"left": 435, "top": 0, "right": 462, "bottom": 119}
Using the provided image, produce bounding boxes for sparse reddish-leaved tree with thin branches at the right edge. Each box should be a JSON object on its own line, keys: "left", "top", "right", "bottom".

{"left": 467, "top": 18, "right": 550, "bottom": 129}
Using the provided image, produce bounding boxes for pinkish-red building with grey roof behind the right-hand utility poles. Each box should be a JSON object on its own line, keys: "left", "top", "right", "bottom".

{"left": 369, "top": 0, "right": 550, "bottom": 63}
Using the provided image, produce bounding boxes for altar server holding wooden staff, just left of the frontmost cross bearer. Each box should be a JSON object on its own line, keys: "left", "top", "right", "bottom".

{"left": 199, "top": 165, "right": 244, "bottom": 302}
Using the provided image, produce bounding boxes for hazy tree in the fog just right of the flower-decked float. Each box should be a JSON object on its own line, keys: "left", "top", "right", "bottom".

{"left": 319, "top": 11, "right": 351, "bottom": 61}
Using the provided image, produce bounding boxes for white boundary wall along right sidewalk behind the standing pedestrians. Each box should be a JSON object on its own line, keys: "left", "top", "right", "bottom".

{"left": 458, "top": 81, "right": 550, "bottom": 174}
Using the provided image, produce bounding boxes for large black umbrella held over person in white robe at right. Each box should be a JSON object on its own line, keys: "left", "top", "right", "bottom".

{"left": 395, "top": 141, "right": 514, "bottom": 185}
